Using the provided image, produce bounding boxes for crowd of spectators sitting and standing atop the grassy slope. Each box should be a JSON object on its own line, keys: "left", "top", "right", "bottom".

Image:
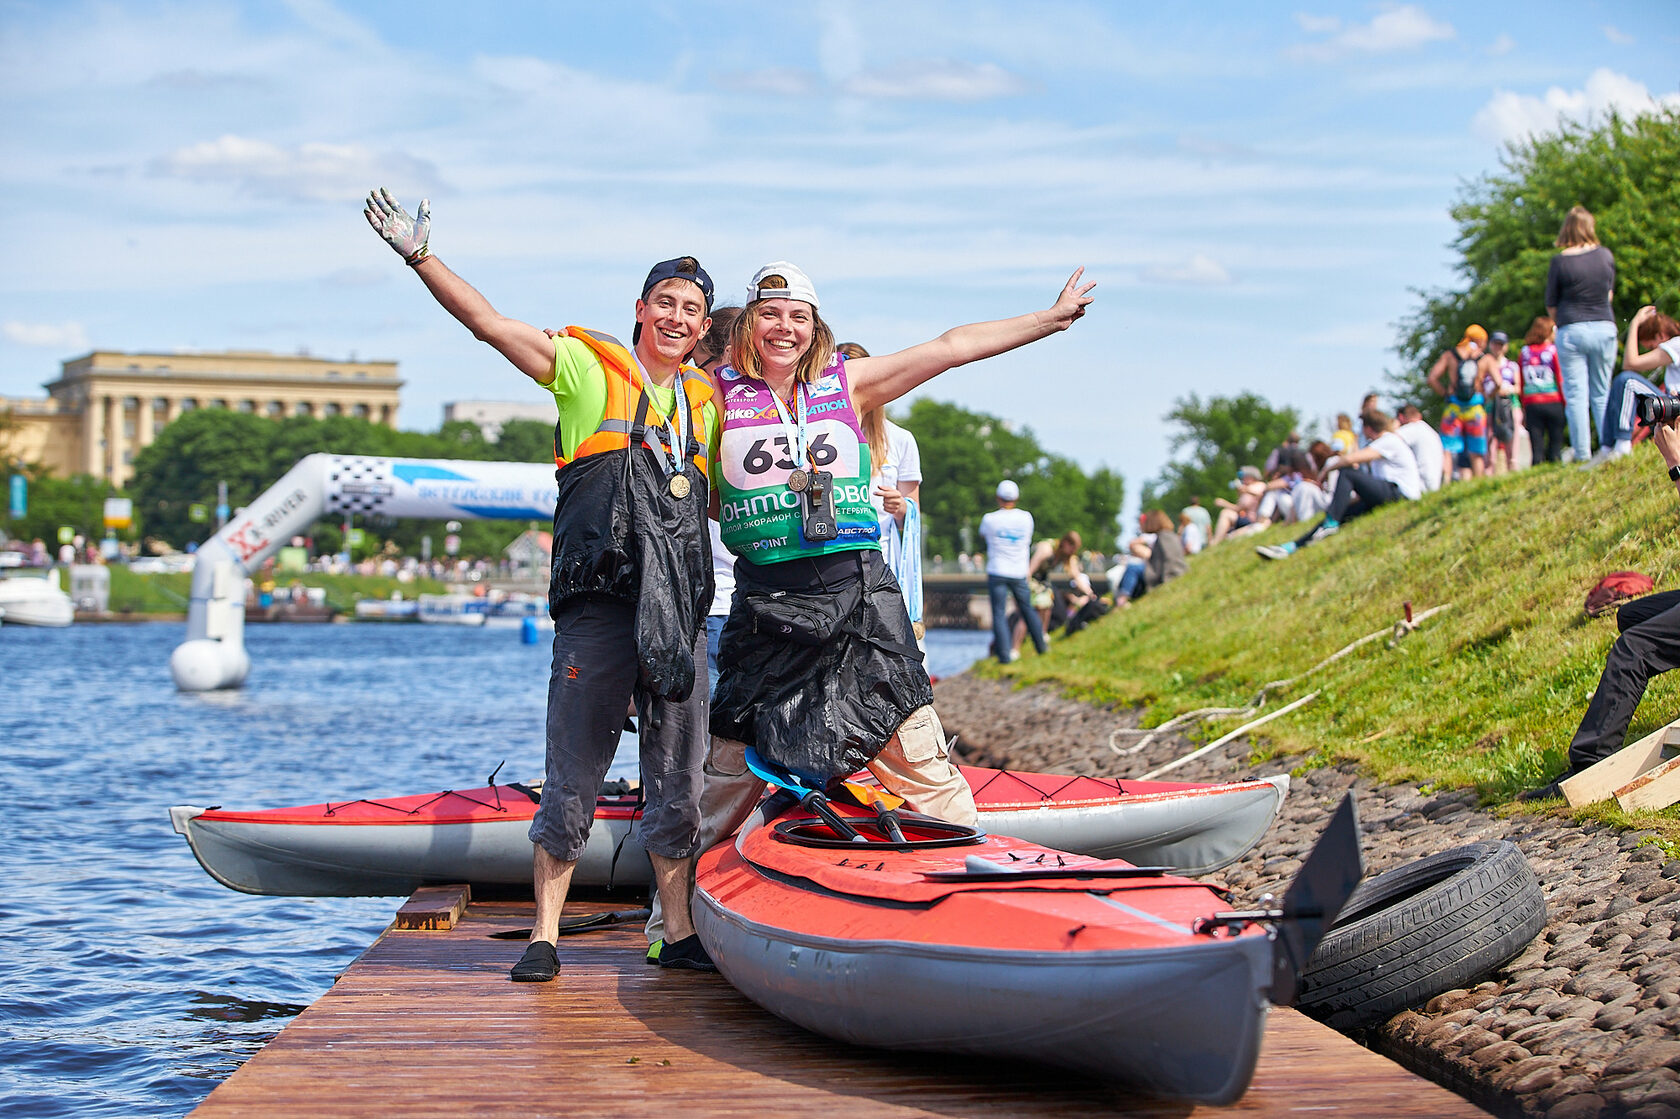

{"left": 1135, "top": 207, "right": 1680, "bottom": 560}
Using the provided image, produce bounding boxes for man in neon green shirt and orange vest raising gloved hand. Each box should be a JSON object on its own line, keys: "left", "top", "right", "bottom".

{"left": 365, "top": 190, "right": 719, "bottom": 983}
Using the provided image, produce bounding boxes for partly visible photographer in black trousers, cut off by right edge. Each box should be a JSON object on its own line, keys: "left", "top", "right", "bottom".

{"left": 1517, "top": 379, "right": 1680, "bottom": 800}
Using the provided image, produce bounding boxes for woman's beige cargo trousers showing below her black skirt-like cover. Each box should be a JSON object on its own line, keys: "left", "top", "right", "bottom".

{"left": 647, "top": 704, "right": 979, "bottom": 944}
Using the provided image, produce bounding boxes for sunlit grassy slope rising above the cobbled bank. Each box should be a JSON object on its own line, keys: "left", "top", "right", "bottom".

{"left": 991, "top": 445, "right": 1680, "bottom": 835}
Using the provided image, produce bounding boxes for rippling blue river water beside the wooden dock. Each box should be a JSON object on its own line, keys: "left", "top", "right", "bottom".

{"left": 0, "top": 623, "right": 990, "bottom": 1116}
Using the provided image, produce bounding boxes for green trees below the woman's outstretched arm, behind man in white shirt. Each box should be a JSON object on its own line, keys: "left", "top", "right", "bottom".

{"left": 894, "top": 400, "right": 1126, "bottom": 558}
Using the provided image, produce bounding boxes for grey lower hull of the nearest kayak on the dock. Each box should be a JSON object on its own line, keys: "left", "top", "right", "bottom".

{"left": 694, "top": 860, "right": 1272, "bottom": 1104}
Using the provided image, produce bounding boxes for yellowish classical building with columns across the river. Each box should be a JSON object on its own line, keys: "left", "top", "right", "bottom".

{"left": 0, "top": 349, "right": 403, "bottom": 486}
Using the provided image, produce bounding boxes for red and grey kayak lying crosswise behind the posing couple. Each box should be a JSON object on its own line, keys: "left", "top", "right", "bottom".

{"left": 170, "top": 766, "right": 1289, "bottom": 897}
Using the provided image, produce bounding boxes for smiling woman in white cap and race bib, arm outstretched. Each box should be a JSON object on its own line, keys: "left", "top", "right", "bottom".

{"left": 701, "top": 262, "right": 1094, "bottom": 833}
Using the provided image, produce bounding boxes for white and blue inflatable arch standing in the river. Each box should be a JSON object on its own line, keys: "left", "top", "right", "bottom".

{"left": 170, "top": 454, "right": 554, "bottom": 692}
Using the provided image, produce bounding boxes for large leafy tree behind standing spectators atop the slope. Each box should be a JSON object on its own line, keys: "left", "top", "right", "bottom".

{"left": 1391, "top": 108, "right": 1680, "bottom": 408}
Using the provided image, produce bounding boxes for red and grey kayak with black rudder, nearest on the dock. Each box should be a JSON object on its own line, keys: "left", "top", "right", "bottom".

{"left": 694, "top": 795, "right": 1361, "bottom": 1104}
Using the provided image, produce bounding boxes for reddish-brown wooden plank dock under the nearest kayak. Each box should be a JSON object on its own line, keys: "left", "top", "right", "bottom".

{"left": 193, "top": 901, "right": 1487, "bottom": 1119}
